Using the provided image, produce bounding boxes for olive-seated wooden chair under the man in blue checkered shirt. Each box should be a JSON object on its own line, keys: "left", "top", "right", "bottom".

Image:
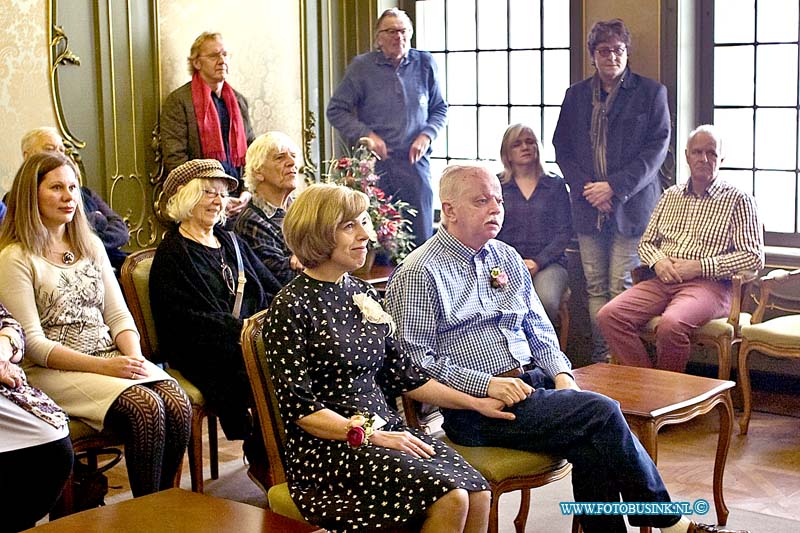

{"left": 403, "top": 396, "right": 580, "bottom": 533}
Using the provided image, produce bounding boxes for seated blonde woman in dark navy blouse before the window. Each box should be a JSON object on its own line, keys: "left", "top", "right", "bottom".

{"left": 497, "top": 124, "right": 572, "bottom": 325}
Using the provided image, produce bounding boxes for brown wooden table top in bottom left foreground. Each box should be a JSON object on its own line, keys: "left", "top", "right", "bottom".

{"left": 28, "top": 489, "right": 324, "bottom": 533}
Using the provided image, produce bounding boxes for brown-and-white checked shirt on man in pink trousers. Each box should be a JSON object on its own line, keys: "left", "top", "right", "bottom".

{"left": 639, "top": 178, "right": 764, "bottom": 279}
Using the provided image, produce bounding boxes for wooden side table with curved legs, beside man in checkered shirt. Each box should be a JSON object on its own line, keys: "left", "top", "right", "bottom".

{"left": 573, "top": 363, "right": 735, "bottom": 526}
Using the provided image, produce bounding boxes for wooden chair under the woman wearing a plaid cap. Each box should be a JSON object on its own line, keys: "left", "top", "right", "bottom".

{"left": 120, "top": 248, "right": 219, "bottom": 493}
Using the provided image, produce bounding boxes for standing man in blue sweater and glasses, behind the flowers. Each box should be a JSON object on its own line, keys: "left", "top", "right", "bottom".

{"left": 327, "top": 8, "right": 447, "bottom": 245}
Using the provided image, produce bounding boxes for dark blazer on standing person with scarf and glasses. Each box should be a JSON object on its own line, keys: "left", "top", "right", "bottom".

{"left": 553, "top": 71, "right": 671, "bottom": 237}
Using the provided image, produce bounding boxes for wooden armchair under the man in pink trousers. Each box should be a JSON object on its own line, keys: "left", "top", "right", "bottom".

{"left": 628, "top": 265, "right": 758, "bottom": 380}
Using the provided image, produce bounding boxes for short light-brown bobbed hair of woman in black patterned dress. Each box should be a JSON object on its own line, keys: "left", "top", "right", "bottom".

{"left": 283, "top": 183, "right": 369, "bottom": 268}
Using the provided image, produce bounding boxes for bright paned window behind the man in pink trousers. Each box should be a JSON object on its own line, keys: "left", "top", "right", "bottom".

{"left": 713, "top": 0, "right": 800, "bottom": 246}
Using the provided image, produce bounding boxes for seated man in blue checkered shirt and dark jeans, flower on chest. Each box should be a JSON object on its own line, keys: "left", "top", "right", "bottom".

{"left": 386, "top": 166, "right": 748, "bottom": 533}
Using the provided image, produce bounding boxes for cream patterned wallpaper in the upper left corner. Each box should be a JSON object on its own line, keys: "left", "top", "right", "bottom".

{"left": 0, "top": 0, "right": 56, "bottom": 194}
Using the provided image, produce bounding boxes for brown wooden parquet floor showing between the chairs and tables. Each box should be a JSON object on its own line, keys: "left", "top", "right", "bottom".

{"left": 101, "top": 392, "right": 800, "bottom": 521}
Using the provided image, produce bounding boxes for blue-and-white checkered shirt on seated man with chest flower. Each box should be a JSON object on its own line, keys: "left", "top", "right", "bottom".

{"left": 386, "top": 228, "right": 571, "bottom": 396}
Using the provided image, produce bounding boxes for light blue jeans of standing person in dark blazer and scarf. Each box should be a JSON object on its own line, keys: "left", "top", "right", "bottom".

{"left": 578, "top": 224, "right": 641, "bottom": 362}
